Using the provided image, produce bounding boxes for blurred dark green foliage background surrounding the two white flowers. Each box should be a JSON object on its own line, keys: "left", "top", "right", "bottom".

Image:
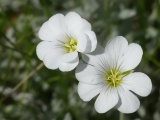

{"left": 0, "top": 0, "right": 160, "bottom": 120}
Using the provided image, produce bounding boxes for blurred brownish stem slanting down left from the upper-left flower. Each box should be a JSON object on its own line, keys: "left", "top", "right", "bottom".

{"left": 0, "top": 63, "right": 44, "bottom": 103}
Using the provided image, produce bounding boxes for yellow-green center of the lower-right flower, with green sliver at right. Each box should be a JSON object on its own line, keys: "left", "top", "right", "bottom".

{"left": 105, "top": 69, "right": 132, "bottom": 87}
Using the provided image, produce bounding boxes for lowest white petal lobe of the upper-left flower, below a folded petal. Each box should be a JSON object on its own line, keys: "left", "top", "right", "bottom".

{"left": 59, "top": 57, "right": 79, "bottom": 72}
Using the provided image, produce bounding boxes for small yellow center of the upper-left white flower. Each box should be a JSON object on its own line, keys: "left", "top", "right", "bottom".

{"left": 64, "top": 38, "right": 77, "bottom": 53}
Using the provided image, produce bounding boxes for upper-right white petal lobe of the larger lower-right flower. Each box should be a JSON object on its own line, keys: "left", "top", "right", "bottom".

{"left": 120, "top": 43, "right": 143, "bottom": 72}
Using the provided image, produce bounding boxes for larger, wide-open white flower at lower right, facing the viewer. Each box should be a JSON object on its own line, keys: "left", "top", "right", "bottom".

{"left": 76, "top": 36, "right": 152, "bottom": 113}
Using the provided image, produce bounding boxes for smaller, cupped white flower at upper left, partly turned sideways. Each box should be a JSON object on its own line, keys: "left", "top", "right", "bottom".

{"left": 36, "top": 12, "right": 97, "bottom": 71}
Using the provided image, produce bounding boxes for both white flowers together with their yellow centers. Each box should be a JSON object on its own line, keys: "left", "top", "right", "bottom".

{"left": 36, "top": 12, "right": 152, "bottom": 113}
